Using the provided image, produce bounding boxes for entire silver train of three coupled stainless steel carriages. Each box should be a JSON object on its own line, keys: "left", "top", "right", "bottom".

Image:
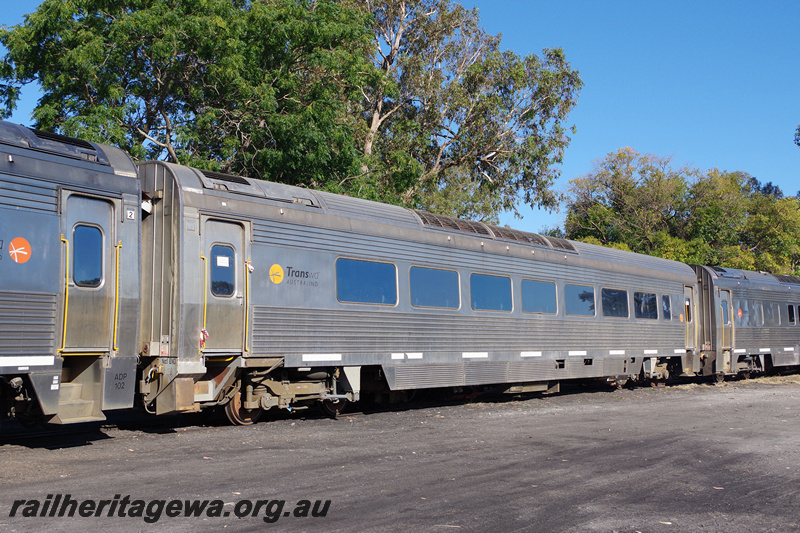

{"left": 0, "top": 123, "right": 800, "bottom": 424}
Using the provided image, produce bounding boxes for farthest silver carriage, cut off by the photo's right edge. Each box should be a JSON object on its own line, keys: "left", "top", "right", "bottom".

{"left": 694, "top": 266, "right": 800, "bottom": 377}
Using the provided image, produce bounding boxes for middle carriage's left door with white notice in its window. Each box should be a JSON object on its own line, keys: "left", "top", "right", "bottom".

{"left": 203, "top": 220, "right": 247, "bottom": 353}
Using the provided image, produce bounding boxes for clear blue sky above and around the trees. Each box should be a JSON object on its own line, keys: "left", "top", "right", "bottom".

{"left": 0, "top": 0, "right": 800, "bottom": 232}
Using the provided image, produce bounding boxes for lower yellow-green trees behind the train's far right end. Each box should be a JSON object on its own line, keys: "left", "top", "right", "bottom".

{"left": 565, "top": 148, "right": 800, "bottom": 275}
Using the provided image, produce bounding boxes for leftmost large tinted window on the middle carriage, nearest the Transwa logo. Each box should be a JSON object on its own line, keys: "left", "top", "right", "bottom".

{"left": 336, "top": 259, "right": 397, "bottom": 305}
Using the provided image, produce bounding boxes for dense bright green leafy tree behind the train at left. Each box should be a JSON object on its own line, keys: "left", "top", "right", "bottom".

{"left": 0, "top": 0, "right": 370, "bottom": 186}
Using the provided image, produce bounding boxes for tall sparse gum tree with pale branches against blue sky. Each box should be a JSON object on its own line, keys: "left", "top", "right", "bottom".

{"left": 356, "top": 0, "right": 581, "bottom": 220}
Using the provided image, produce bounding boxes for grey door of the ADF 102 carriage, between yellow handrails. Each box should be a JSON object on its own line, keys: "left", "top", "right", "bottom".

{"left": 62, "top": 193, "right": 117, "bottom": 355}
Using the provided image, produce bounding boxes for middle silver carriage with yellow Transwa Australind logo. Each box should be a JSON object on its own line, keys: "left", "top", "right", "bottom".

{"left": 139, "top": 162, "right": 700, "bottom": 423}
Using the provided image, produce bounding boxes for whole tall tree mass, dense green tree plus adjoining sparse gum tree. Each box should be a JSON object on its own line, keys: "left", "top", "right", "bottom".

{"left": 0, "top": 0, "right": 581, "bottom": 220}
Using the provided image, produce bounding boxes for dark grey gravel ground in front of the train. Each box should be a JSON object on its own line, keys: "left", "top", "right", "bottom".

{"left": 0, "top": 376, "right": 800, "bottom": 533}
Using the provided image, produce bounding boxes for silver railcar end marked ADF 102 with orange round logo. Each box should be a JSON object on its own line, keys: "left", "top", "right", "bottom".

{"left": 0, "top": 122, "right": 140, "bottom": 423}
